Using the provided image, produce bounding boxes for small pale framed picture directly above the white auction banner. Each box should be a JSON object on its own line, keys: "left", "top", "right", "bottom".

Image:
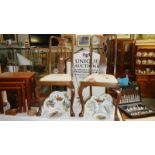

{"left": 77, "top": 35, "right": 90, "bottom": 46}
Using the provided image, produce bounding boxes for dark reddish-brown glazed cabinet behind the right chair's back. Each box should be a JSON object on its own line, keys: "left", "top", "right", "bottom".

{"left": 107, "top": 39, "right": 135, "bottom": 78}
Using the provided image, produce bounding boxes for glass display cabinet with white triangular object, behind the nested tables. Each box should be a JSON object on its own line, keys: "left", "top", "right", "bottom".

{"left": 0, "top": 46, "right": 49, "bottom": 76}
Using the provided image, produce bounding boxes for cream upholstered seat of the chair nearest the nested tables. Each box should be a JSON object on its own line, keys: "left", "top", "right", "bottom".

{"left": 40, "top": 74, "right": 71, "bottom": 82}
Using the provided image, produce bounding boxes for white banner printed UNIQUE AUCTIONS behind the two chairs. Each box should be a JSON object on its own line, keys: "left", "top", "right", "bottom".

{"left": 72, "top": 50, "right": 105, "bottom": 97}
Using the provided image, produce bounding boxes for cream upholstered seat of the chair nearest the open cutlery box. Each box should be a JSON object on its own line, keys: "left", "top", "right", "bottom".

{"left": 82, "top": 74, "right": 118, "bottom": 83}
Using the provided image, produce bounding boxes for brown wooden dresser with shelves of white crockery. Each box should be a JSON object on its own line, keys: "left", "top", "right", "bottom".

{"left": 135, "top": 45, "right": 155, "bottom": 98}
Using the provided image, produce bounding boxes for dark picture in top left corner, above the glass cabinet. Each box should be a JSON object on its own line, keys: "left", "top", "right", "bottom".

{"left": 1, "top": 34, "right": 18, "bottom": 44}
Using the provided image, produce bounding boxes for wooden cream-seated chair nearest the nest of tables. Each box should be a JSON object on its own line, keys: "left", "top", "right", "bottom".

{"left": 39, "top": 36, "right": 75, "bottom": 116}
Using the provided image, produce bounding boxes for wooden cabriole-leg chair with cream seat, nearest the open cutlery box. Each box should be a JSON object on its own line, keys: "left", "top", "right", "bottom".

{"left": 78, "top": 35, "right": 121, "bottom": 120}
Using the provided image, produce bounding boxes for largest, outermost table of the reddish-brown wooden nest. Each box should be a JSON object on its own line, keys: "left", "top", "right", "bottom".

{"left": 0, "top": 72, "right": 35, "bottom": 109}
